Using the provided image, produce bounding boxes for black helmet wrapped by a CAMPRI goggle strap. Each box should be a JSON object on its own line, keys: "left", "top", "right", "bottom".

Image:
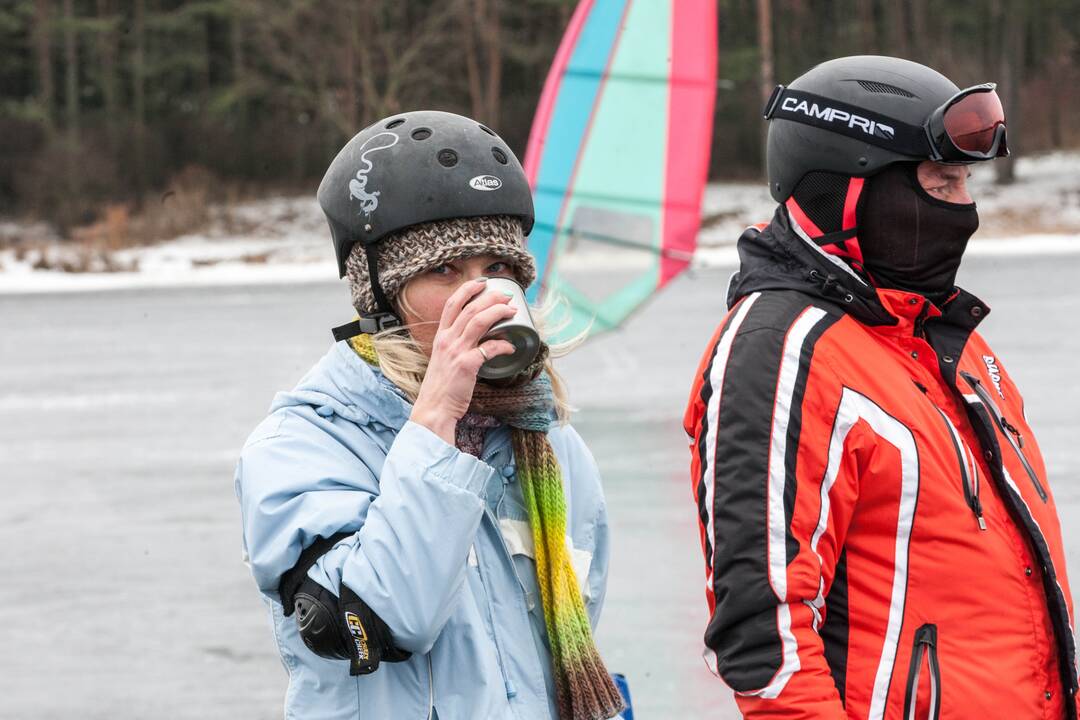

{"left": 765, "top": 55, "right": 1008, "bottom": 203}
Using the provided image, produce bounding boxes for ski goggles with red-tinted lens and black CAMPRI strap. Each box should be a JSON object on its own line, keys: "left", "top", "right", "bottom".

{"left": 764, "top": 82, "right": 1009, "bottom": 163}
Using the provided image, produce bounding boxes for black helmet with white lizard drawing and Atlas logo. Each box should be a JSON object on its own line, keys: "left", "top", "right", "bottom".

{"left": 319, "top": 110, "right": 534, "bottom": 278}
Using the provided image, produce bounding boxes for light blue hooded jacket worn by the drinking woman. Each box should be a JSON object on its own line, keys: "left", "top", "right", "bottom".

{"left": 237, "top": 342, "right": 609, "bottom": 720}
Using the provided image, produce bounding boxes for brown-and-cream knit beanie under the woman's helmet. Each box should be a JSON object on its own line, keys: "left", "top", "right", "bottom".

{"left": 346, "top": 215, "right": 537, "bottom": 314}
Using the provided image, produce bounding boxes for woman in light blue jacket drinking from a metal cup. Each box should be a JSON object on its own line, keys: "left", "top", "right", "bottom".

{"left": 237, "top": 111, "right": 622, "bottom": 720}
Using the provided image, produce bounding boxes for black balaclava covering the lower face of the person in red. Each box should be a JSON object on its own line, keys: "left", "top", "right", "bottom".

{"left": 859, "top": 163, "right": 978, "bottom": 304}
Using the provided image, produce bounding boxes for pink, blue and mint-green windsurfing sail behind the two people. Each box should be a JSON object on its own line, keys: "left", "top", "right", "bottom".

{"left": 525, "top": 0, "right": 716, "bottom": 336}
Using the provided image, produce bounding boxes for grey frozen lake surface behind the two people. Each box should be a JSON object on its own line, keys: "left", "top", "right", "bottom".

{"left": 0, "top": 254, "right": 1080, "bottom": 720}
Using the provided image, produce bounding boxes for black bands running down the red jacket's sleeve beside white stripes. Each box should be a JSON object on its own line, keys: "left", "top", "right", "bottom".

{"left": 705, "top": 291, "right": 840, "bottom": 692}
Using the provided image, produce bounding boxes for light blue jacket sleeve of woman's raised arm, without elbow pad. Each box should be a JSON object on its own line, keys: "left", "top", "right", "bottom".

{"left": 237, "top": 406, "right": 494, "bottom": 653}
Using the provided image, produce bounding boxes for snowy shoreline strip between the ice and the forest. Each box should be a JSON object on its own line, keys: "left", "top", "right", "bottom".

{"left": 0, "top": 151, "right": 1080, "bottom": 293}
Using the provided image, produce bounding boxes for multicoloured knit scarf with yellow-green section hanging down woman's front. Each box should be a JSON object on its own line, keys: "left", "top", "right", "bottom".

{"left": 350, "top": 335, "right": 624, "bottom": 720}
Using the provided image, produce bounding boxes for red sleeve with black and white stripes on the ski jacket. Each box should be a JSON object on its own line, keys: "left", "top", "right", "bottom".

{"left": 684, "top": 296, "right": 856, "bottom": 720}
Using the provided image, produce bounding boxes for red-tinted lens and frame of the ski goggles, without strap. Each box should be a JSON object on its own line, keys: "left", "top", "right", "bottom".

{"left": 923, "top": 82, "right": 1009, "bottom": 162}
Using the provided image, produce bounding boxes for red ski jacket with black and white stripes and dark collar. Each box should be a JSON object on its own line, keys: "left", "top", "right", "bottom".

{"left": 685, "top": 212, "right": 1078, "bottom": 720}
